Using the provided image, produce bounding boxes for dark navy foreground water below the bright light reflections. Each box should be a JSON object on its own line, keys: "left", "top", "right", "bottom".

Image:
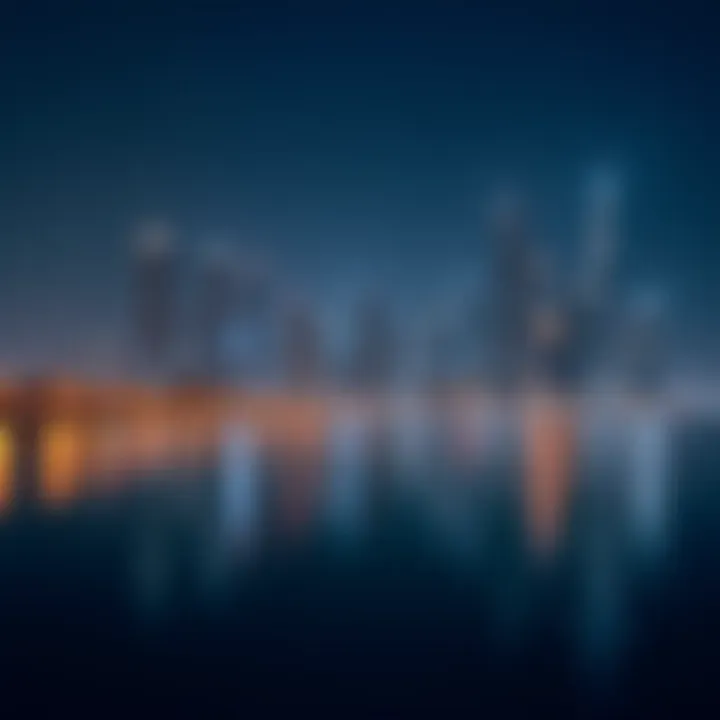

{"left": 0, "top": 420, "right": 720, "bottom": 717}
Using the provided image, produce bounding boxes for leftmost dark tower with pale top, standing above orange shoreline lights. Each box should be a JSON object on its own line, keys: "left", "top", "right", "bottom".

{"left": 132, "top": 221, "right": 178, "bottom": 378}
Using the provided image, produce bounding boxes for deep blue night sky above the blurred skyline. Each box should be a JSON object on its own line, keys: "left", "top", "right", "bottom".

{"left": 0, "top": 0, "right": 720, "bottom": 376}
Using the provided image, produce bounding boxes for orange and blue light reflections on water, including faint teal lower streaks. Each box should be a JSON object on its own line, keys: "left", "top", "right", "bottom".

{"left": 0, "top": 402, "right": 696, "bottom": 688}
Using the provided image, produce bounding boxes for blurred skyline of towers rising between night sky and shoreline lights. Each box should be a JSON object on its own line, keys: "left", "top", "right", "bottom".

{"left": 133, "top": 178, "right": 667, "bottom": 391}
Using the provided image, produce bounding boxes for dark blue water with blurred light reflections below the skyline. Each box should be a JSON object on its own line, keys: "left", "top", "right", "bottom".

{"left": 0, "top": 390, "right": 720, "bottom": 715}
